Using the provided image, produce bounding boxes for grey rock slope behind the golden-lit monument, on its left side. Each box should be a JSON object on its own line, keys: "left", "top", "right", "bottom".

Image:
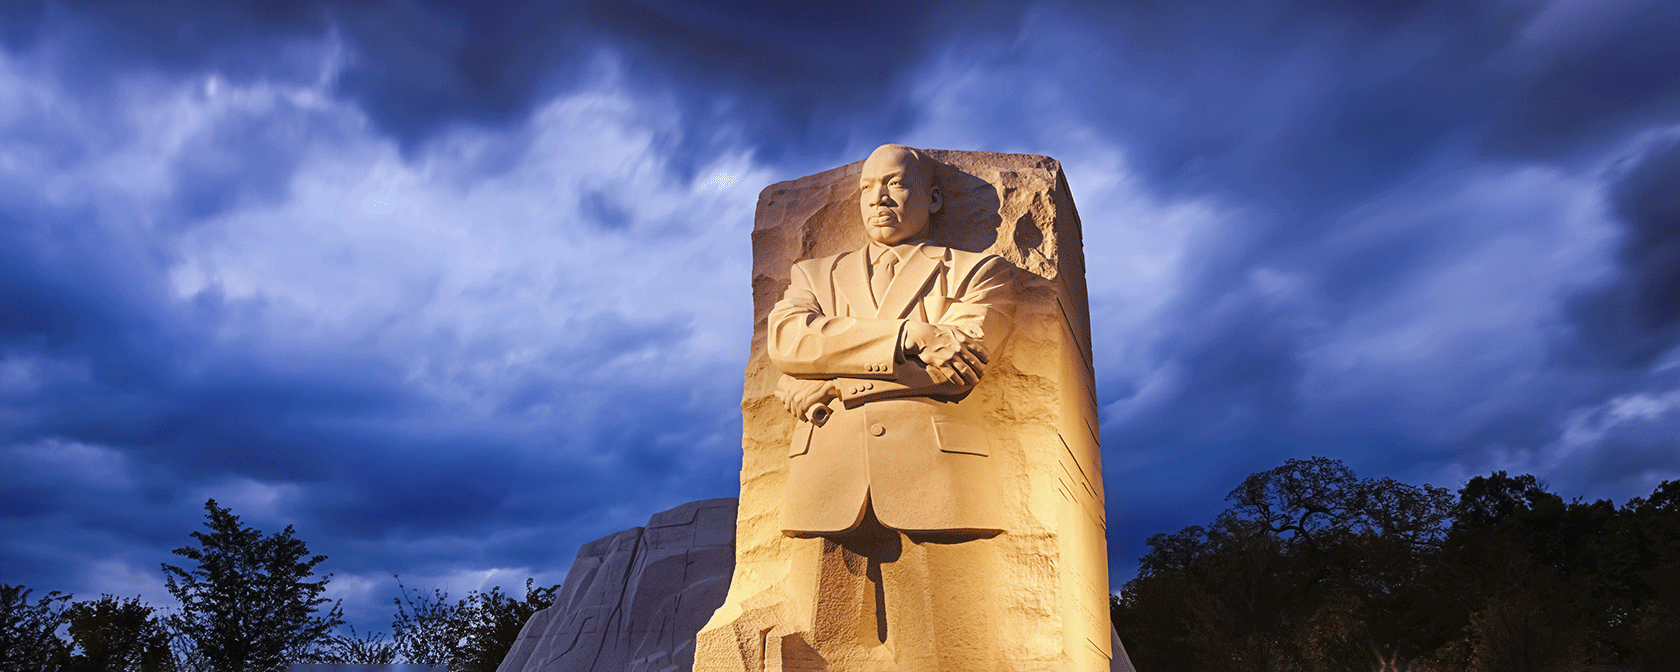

{"left": 497, "top": 499, "right": 736, "bottom": 672}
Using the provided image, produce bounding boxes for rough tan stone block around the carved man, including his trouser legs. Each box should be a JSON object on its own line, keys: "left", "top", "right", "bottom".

{"left": 696, "top": 150, "right": 1112, "bottom": 672}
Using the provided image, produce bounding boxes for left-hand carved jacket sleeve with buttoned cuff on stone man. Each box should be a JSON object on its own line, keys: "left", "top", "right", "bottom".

{"left": 766, "top": 259, "right": 904, "bottom": 380}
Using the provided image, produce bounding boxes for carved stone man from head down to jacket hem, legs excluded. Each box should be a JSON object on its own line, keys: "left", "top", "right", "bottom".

{"left": 768, "top": 144, "right": 1013, "bottom": 536}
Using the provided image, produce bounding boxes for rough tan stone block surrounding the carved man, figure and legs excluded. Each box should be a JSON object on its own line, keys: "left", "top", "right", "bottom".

{"left": 696, "top": 150, "right": 1131, "bottom": 672}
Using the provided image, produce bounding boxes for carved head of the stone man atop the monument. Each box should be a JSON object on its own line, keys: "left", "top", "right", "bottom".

{"left": 858, "top": 144, "right": 941, "bottom": 245}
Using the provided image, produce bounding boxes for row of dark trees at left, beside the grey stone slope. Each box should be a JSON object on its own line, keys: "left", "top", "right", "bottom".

{"left": 0, "top": 499, "right": 559, "bottom": 672}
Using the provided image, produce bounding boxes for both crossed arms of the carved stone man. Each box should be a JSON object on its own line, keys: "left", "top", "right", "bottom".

{"left": 768, "top": 257, "right": 1013, "bottom": 418}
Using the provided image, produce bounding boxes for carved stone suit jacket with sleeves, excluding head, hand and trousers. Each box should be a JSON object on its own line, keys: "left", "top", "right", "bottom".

{"left": 768, "top": 245, "right": 1015, "bottom": 536}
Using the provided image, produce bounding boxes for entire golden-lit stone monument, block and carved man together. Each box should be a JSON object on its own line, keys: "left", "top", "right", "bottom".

{"left": 694, "top": 144, "right": 1126, "bottom": 672}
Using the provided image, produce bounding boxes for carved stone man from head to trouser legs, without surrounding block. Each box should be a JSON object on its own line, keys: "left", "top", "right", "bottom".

{"left": 766, "top": 144, "right": 1015, "bottom": 670}
